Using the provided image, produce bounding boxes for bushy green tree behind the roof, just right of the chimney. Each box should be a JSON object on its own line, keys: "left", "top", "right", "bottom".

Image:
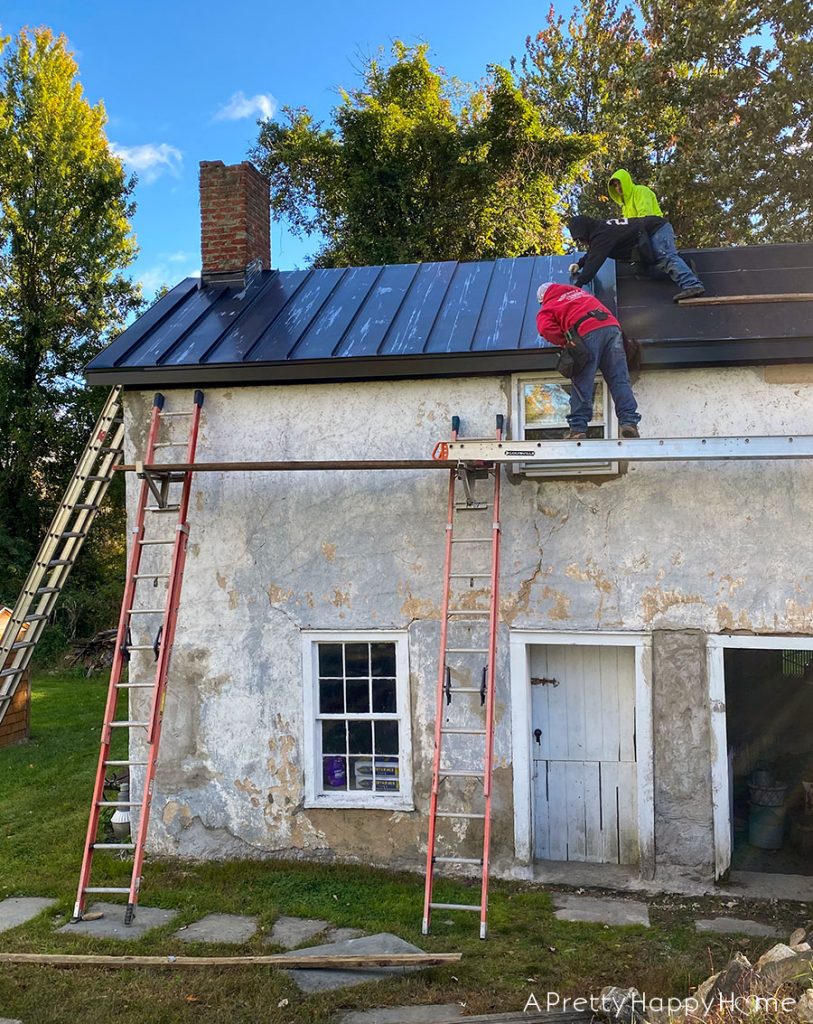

{"left": 252, "top": 42, "right": 597, "bottom": 266}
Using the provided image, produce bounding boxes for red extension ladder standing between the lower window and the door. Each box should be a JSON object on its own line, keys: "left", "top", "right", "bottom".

{"left": 422, "top": 416, "right": 504, "bottom": 939}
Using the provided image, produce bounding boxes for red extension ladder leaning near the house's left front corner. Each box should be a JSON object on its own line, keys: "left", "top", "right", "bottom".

{"left": 71, "top": 391, "right": 203, "bottom": 925}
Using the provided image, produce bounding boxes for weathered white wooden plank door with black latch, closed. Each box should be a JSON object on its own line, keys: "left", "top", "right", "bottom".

{"left": 530, "top": 644, "right": 639, "bottom": 864}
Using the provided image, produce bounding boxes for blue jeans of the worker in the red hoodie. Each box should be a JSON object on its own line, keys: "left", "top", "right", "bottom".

{"left": 567, "top": 327, "right": 641, "bottom": 433}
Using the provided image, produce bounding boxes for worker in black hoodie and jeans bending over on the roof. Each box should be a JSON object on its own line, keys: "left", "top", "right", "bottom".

{"left": 567, "top": 211, "right": 705, "bottom": 302}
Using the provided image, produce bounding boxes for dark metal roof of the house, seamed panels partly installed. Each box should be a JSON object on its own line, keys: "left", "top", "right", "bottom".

{"left": 87, "top": 245, "right": 813, "bottom": 387}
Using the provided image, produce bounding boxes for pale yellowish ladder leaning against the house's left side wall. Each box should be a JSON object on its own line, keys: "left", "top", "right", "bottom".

{"left": 0, "top": 387, "right": 124, "bottom": 722}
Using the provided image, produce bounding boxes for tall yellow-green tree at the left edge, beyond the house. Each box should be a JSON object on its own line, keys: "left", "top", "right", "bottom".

{"left": 0, "top": 29, "right": 140, "bottom": 638}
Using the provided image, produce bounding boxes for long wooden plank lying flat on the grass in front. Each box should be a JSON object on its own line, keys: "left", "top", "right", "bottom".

{"left": 0, "top": 953, "right": 463, "bottom": 971}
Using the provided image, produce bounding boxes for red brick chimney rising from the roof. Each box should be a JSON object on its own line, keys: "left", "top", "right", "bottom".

{"left": 201, "top": 160, "right": 271, "bottom": 287}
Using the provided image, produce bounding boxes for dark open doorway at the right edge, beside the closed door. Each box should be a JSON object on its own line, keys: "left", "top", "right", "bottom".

{"left": 725, "top": 645, "right": 813, "bottom": 874}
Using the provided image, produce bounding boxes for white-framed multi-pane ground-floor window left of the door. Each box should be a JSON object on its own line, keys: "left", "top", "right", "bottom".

{"left": 302, "top": 630, "right": 414, "bottom": 810}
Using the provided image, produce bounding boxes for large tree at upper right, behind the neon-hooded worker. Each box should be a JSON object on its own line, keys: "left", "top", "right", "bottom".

{"left": 519, "top": 0, "right": 813, "bottom": 246}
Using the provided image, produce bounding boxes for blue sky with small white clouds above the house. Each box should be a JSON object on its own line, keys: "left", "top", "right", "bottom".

{"left": 0, "top": 0, "right": 571, "bottom": 297}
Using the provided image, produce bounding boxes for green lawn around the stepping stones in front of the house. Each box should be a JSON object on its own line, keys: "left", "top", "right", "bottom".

{"left": 0, "top": 674, "right": 807, "bottom": 1024}
